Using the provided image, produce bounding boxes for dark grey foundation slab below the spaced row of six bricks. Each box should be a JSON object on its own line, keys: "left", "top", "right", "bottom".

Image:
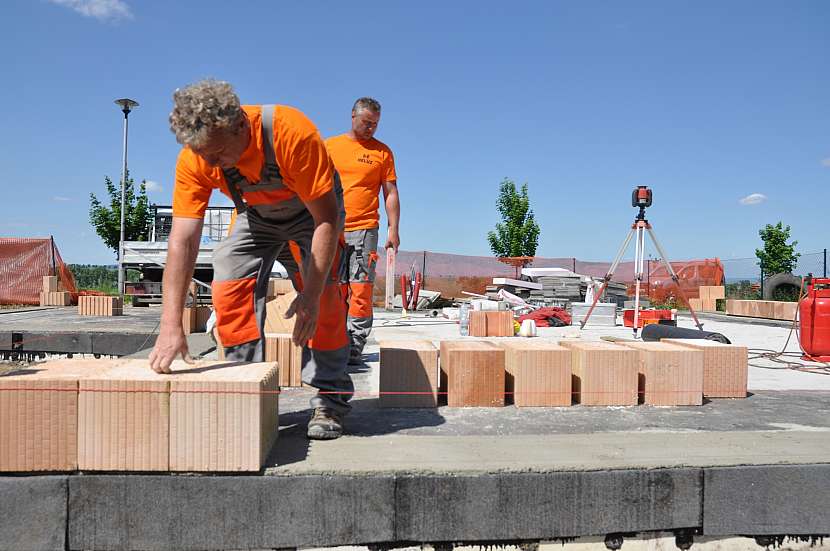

{"left": 395, "top": 469, "right": 702, "bottom": 542}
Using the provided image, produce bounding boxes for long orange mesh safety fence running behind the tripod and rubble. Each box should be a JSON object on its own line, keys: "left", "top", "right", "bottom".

{"left": 374, "top": 250, "right": 724, "bottom": 305}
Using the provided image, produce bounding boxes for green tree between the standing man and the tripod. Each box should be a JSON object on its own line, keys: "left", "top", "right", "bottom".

{"left": 487, "top": 178, "right": 539, "bottom": 257}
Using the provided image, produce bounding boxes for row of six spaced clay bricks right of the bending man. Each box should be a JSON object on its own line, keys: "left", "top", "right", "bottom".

{"left": 380, "top": 339, "right": 748, "bottom": 407}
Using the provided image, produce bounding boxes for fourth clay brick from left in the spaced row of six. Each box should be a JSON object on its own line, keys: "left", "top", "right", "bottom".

{"left": 559, "top": 340, "right": 639, "bottom": 406}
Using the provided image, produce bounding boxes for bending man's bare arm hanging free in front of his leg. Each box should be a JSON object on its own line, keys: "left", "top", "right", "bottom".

{"left": 285, "top": 190, "right": 343, "bottom": 346}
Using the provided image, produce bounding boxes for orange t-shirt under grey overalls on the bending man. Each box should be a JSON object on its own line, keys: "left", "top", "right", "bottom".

{"left": 173, "top": 105, "right": 334, "bottom": 218}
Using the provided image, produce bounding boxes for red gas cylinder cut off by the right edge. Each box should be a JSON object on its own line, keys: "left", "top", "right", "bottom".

{"left": 798, "top": 278, "right": 830, "bottom": 362}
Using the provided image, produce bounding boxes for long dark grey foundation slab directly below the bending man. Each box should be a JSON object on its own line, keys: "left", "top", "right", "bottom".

{"left": 67, "top": 475, "right": 395, "bottom": 551}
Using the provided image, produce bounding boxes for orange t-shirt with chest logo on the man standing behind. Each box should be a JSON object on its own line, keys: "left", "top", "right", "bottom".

{"left": 326, "top": 134, "right": 398, "bottom": 231}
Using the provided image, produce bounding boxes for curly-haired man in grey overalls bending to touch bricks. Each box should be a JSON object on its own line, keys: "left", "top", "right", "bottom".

{"left": 150, "top": 80, "right": 354, "bottom": 440}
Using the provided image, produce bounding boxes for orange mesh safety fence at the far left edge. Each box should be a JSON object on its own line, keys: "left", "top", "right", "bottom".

{"left": 0, "top": 237, "right": 78, "bottom": 305}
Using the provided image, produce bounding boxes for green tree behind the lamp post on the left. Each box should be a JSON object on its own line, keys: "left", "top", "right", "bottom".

{"left": 89, "top": 174, "right": 153, "bottom": 257}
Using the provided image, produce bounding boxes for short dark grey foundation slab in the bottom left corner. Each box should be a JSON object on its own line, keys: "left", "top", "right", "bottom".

{"left": 0, "top": 476, "right": 67, "bottom": 551}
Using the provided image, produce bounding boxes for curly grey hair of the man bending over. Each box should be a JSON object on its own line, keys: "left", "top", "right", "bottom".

{"left": 170, "top": 79, "right": 243, "bottom": 147}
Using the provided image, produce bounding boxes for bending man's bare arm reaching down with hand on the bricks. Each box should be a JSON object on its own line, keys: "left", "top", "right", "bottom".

{"left": 150, "top": 216, "right": 203, "bottom": 373}
